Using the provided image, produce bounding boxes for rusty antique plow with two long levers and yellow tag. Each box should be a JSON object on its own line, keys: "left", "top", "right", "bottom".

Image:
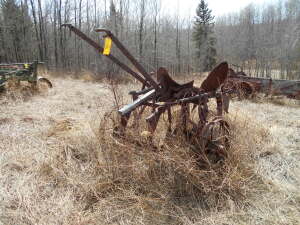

{"left": 63, "top": 24, "right": 230, "bottom": 155}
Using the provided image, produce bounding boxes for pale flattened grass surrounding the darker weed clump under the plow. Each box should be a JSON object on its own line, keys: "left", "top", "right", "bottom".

{"left": 0, "top": 79, "right": 300, "bottom": 225}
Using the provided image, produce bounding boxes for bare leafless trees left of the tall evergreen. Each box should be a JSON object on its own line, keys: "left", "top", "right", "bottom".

{"left": 0, "top": 0, "right": 193, "bottom": 73}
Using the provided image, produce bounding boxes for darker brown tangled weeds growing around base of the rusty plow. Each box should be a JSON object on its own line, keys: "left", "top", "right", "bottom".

{"left": 95, "top": 109, "right": 267, "bottom": 203}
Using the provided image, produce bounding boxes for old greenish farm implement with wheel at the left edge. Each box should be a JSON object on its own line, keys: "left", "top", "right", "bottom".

{"left": 0, "top": 61, "right": 52, "bottom": 89}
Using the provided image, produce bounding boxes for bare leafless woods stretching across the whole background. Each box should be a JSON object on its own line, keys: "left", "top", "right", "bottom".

{"left": 0, "top": 0, "right": 300, "bottom": 79}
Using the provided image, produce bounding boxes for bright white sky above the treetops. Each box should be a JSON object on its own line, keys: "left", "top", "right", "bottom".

{"left": 161, "top": 0, "right": 276, "bottom": 17}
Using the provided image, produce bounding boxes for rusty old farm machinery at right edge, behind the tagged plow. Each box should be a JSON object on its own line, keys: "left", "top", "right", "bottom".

{"left": 224, "top": 69, "right": 300, "bottom": 100}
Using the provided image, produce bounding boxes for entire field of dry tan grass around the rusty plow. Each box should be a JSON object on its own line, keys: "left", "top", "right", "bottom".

{"left": 0, "top": 78, "right": 300, "bottom": 225}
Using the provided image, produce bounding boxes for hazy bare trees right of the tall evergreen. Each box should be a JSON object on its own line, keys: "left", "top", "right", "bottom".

{"left": 215, "top": 0, "right": 300, "bottom": 79}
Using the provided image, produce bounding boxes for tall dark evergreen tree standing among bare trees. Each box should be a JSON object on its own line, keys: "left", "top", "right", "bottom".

{"left": 193, "top": 0, "right": 217, "bottom": 71}
